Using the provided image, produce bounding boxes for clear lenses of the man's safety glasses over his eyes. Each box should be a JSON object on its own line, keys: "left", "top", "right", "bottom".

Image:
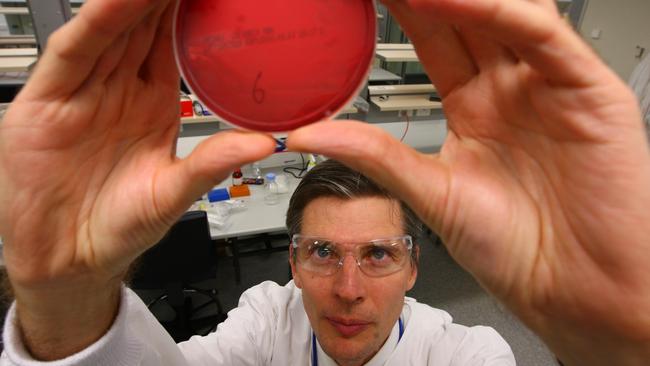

{"left": 292, "top": 235, "right": 413, "bottom": 277}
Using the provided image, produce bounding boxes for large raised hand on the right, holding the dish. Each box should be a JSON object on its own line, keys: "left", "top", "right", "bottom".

{"left": 289, "top": 0, "right": 650, "bottom": 365}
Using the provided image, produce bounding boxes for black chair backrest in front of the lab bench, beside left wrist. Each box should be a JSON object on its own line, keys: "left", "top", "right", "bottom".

{"left": 131, "top": 211, "right": 217, "bottom": 289}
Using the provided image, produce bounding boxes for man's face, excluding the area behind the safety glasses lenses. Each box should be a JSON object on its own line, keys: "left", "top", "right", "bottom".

{"left": 291, "top": 197, "right": 417, "bottom": 365}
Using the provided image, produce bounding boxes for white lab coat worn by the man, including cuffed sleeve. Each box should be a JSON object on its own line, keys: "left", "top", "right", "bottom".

{"left": 0, "top": 282, "right": 515, "bottom": 366}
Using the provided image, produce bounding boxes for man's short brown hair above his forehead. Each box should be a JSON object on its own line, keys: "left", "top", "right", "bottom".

{"left": 286, "top": 160, "right": 422, "bottom": 263}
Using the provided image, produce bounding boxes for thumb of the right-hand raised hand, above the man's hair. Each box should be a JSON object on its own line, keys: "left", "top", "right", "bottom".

{"left": 287, "top": 121, "right": 450, "bottom": 231}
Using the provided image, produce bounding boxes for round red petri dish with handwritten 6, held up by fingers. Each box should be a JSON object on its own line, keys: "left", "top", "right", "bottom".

{"left": 174, "top": 0, "right": 377, "bottom": 132}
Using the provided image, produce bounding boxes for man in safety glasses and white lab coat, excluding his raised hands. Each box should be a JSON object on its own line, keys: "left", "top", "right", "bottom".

{"left": 0, "top": 160, "right": 515, "bottom": 366}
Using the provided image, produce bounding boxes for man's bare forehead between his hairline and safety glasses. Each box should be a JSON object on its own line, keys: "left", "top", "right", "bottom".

{"left": 301, "top": 197, "right": 404, "bottom": 242}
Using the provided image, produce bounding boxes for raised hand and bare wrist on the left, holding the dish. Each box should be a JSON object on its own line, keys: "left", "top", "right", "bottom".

{"left": 0, "top": 0, "right": 274, "bottom": 359}
